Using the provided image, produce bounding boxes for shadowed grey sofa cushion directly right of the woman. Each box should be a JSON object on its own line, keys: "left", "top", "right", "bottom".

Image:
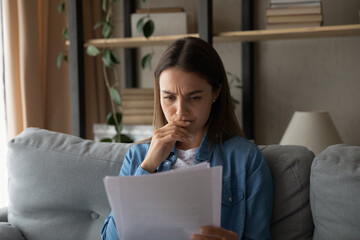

{"left": 260, "top": 145, "right": 314, "bottom": 240}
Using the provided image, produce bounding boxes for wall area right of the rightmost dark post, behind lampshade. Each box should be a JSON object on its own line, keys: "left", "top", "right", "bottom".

{"left": 255, "top": 0, "right": 360, "bottom": 145}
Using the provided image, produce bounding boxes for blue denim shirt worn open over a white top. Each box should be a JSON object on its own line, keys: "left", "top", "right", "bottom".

{"left": 101, "top": 135, "right": 273, "bottom": 240}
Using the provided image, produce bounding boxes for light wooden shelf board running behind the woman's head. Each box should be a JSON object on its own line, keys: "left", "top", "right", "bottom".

{"left": 71, "top": 24, "right": 360, "bottom": 48}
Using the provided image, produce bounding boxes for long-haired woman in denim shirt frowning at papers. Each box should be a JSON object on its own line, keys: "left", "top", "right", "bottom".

{"left": 102, "top": 37, "right": 273, "bottom": 239}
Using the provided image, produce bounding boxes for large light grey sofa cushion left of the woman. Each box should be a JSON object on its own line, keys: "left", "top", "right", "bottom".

{"left": 8, "top": 128, "right": 132, "bottom": 240}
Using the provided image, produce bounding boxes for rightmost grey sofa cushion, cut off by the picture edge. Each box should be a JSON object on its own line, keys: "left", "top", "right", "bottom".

{"left": 310, "top": 145, "right": 360, "bottom": 239}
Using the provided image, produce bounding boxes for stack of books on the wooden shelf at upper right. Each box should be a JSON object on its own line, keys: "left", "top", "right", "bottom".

{"left": 266, "top": 0, "right": 323, "bottom": 29}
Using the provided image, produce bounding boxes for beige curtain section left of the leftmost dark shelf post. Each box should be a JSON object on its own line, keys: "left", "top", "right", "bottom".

{"left": 3, "top": 0, "right": 71, "bottom": 138}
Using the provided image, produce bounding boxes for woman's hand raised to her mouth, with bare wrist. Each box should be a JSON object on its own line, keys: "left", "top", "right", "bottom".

{"left": 140, "top": 120, "right": 190, "bottom": 173}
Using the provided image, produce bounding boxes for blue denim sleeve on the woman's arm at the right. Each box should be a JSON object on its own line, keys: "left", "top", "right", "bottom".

{"left": 243, "top": 148, "right": 273, "bottom": 239}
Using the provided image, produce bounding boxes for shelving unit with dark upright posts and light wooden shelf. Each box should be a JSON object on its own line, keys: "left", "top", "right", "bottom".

{"left": 67, "top": 0, "right": 360, "bottom": 138}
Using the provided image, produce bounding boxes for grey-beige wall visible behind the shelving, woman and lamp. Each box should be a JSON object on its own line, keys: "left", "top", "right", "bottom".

{"left": 112, "top": 0, "right": 360, "bottom": 145}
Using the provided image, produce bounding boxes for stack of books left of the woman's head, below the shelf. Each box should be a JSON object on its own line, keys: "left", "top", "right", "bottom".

{"left": 121, "top": 88, "right": 154, "bottom": 125}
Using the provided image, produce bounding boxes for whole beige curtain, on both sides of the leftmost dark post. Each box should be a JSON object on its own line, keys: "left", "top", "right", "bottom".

{"left": 3, "top": 0, "right": 108, "bottom": 139}
